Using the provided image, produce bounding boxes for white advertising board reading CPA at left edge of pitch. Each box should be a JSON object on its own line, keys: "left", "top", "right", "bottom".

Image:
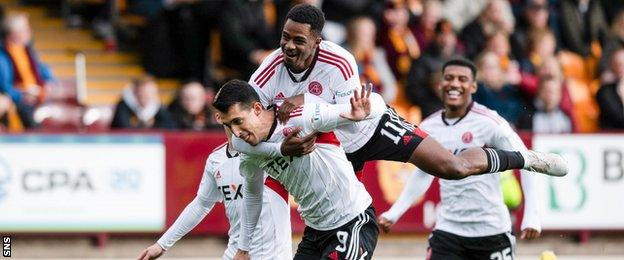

{"left": 0, "top": 135, "right": 165, "bottom": 232}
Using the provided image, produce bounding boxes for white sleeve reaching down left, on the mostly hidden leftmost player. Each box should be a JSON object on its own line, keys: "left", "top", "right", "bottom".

{"left": 156, "top": 154, "right": 223, "bottom": 250}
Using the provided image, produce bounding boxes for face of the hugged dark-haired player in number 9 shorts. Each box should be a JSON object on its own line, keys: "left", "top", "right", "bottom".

{"left": 219, "top": 103, "right": 262, "bottom": 145}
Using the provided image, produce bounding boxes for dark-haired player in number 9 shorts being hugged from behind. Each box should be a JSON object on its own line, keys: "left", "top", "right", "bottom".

{"left": 213, "top": 80, "right": 385, "bottom": 259}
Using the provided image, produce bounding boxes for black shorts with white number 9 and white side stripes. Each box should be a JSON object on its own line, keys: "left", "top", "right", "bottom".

{"left": 294, "top": 205, "right": 379, "bottom": 260}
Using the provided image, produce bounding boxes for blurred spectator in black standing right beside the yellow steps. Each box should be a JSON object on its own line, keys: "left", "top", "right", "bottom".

{"left": 144, "top": 0, "right": 225, "bottom": 86}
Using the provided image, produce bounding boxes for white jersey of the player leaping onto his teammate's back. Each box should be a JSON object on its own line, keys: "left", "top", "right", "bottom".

{"left": 249, "top": 41, "right": 381, "bottom": 153}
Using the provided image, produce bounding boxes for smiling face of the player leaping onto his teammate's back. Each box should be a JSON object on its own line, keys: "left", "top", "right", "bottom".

{"left": 280, "top": 19, "right": 321, "bottom": 73}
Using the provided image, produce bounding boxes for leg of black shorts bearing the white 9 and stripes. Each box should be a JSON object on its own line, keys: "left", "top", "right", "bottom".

{"left": 321, "top": 206, "right": 379, "bottom": 260}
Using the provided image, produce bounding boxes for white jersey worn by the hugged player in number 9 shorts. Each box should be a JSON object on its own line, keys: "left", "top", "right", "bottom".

{"left": 241, "top": 104, "right": 372, "bottom": 230}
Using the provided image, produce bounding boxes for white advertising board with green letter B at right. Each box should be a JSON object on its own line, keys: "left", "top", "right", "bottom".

{"left": 533, "top": 134, "right": 624, "bottom": 230}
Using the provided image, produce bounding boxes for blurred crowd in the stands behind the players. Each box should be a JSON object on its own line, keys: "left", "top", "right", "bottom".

{"left": 0, "top": 0, "right": 624, "bottom": 133}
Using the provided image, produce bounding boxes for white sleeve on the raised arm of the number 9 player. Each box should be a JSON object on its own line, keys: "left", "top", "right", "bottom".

{"left": 303, "top": 93, "right": 386, "bottom": 133}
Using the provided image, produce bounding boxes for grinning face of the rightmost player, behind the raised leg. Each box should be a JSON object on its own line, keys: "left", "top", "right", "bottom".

{"left": 440, "top": 65, "right": 477, "bottom": 108}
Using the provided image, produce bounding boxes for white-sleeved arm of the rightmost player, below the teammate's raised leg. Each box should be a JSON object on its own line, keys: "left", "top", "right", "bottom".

{"left": 379, "top": 169, "right": 434, "bottom": 233}
